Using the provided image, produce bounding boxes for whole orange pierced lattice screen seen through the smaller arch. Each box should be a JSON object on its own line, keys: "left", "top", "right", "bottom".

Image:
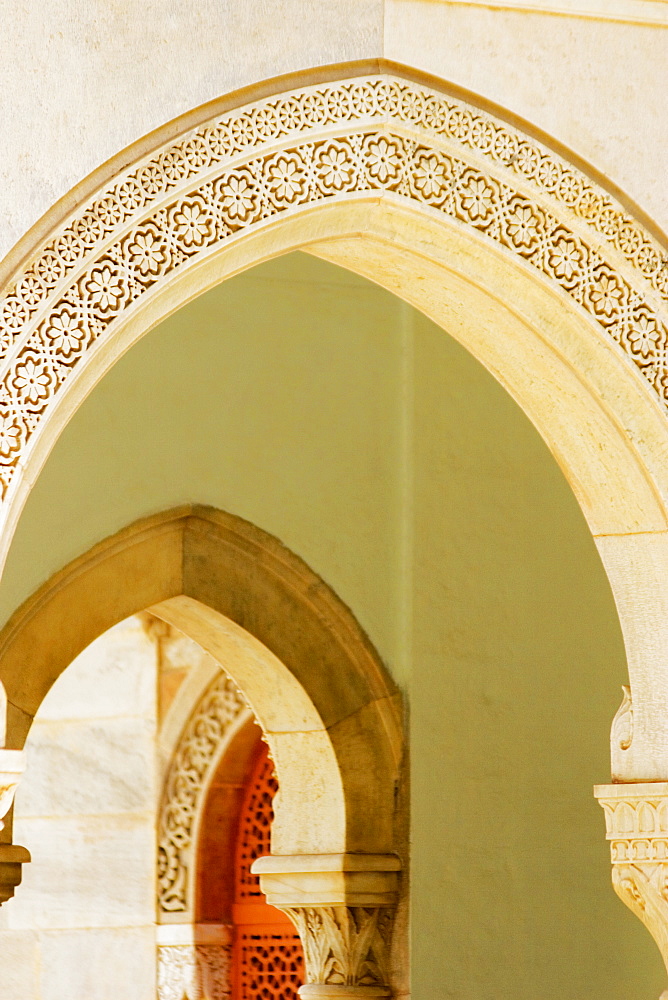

{"left": 232, "top": 743, "right": 304, "bottom": 1000}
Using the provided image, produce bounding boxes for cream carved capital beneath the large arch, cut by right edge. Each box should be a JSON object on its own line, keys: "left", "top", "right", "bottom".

{"left": 594, "top": 781, "right": 668, "bottom": 969}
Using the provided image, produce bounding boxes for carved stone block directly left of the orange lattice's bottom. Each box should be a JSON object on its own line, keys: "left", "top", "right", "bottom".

{"left": 158, "top": 944, "right": 232, "bottom": 1000}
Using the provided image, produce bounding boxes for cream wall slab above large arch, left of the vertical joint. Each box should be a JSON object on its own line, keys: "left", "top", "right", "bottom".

{"left": 0, "top": 0, "right": 383, "bottom": 266}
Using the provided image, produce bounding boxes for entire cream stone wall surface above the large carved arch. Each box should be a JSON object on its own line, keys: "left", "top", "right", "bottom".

{"left": 0, "top": 0, "right": 668, "bottom": 266}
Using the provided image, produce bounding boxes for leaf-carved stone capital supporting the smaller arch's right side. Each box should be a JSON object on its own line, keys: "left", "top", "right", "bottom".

{"left": 251, "top": 854, "right": 401, "bottom": 1000}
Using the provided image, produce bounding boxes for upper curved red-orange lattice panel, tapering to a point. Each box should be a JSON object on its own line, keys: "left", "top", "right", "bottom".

{"left": 234, "top": 744, "right": 278, "bottom": 902}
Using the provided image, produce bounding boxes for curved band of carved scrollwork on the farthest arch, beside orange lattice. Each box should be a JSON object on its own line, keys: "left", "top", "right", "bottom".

{"left": 157, "top": 672, "right": 246, "bottom": 916}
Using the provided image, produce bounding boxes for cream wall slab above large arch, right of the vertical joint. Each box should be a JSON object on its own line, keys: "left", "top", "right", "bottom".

{"left": 383, "top": 0, "right": 668, "bottom": 232}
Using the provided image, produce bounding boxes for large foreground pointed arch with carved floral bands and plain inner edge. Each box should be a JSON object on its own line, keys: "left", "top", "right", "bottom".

{"left": 0, "top": 64, "right": 668, "bottom": 781}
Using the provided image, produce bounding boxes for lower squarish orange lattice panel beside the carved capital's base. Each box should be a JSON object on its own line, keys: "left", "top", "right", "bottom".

{"left": 236, "top": 929, "right": 304, "bottom": 1000}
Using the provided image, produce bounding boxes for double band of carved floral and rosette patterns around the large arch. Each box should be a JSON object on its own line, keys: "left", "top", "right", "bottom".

{"left": 0, "top": 75, "right": 668, "bottom": 496}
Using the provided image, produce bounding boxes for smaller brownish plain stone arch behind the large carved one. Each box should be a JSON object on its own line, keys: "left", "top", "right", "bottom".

{"left": 0, "top": 506, "right": 402, "bottom": 855}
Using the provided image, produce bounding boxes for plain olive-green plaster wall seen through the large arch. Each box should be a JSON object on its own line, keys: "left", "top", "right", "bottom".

{"left": 0, "top": 255, "right": 664, "bottom": 1000}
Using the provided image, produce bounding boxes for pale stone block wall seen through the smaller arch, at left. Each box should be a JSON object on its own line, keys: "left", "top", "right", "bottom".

{"left": 0, "top": 619, "right": 157, "bottom": 1000}
